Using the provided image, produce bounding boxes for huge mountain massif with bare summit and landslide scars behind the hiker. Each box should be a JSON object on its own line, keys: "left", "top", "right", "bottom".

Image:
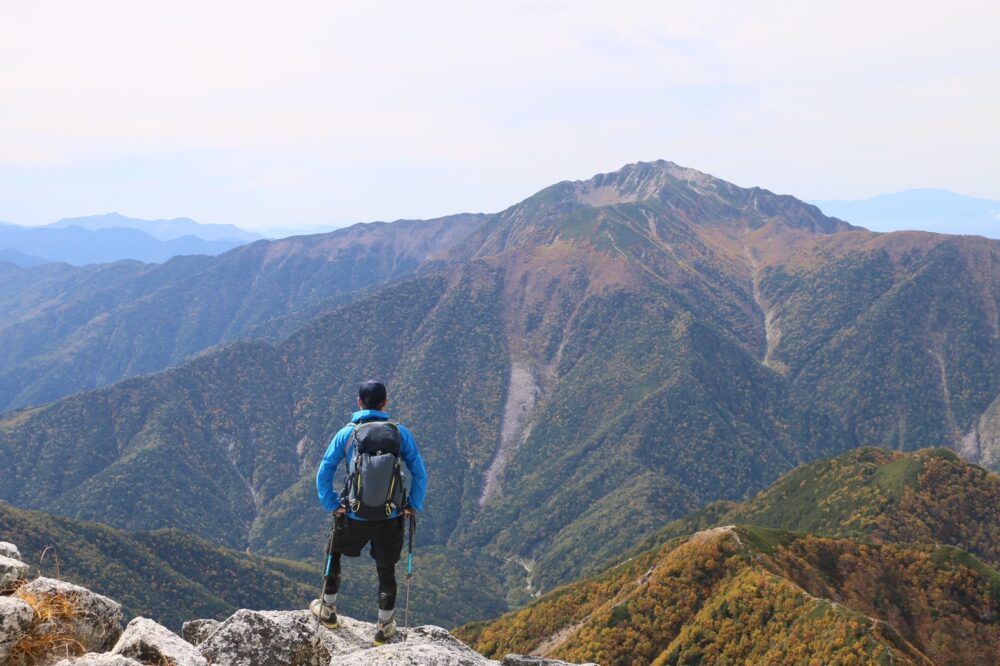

{"left": 0, "top": 161, "right": 1000, "bottom": 644}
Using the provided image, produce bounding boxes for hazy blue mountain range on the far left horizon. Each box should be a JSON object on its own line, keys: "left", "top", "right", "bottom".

{"left": 0, "top": 224, "right": 243, "bottom": 266}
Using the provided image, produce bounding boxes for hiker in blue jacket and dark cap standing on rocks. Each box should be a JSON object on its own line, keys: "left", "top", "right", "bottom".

{"left": 309, "top": 380, "right": 427, "bottom": 645}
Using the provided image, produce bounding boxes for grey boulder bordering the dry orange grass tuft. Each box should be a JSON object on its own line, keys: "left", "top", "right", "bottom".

{"left": 21, "top": 578, "right": 122, "bottom": 652}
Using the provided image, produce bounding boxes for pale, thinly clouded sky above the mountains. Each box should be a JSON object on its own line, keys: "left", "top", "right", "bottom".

{"left": 0, "top": 0, "right": 1000, "bottom": 228}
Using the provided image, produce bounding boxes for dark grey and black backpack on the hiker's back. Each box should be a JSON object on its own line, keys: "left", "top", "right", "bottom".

{"left": 341, "top": 421, "right": 406, "bottom": 520}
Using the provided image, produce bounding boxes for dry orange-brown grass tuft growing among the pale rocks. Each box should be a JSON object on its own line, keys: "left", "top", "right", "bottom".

{"left": 8, "top": 586, "right": 86, "bottom": 666}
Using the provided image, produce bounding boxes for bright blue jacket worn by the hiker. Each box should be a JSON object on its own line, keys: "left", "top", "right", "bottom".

{"left": 316, "top": 409, "right": 427, "bottom": 520}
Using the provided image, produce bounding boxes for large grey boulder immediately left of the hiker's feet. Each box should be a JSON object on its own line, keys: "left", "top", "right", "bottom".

{"left": 192, "top": 610, "right": 330, "bottom": 666}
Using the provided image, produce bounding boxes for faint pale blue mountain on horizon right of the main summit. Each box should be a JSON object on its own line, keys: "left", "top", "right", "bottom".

{"left": 811, "top": 189, "right": 1000, "bottom": 238}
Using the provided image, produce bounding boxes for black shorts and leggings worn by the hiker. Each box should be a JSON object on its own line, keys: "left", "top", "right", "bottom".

{"left": 323, "top": 516, "right": 403, "bottom": 610}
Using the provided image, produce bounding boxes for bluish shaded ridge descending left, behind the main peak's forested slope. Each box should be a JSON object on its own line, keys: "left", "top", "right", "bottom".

{"left": 0, "top": 215, "right": 485, "bottom": 411}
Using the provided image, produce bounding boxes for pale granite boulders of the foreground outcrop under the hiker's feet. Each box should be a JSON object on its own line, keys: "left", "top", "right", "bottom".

{"left": 0, "top": 543, "right": 593, "bottom": 666}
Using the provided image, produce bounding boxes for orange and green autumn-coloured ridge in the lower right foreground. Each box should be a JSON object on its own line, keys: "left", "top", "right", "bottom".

{"left": 456, "top": 448, "right": 1000, "bottom": 664}
